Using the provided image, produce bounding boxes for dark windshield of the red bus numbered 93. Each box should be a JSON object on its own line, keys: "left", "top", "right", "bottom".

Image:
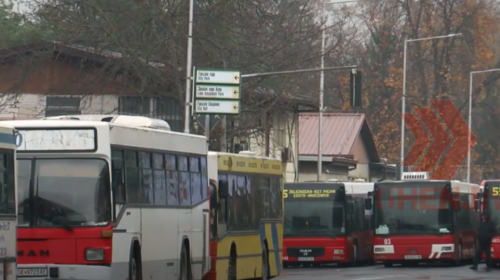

{"left": 374, "top": 184, "right": 453, "bottom": 235}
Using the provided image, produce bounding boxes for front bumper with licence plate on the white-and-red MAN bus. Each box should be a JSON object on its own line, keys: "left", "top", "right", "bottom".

{"left": 17, "top": 264, "right": 112, "bottom": 280}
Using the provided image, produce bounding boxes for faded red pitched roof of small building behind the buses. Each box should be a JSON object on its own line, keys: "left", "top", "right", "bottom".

{"left": 299, "top": 113, "right": 379, "bottom": 162}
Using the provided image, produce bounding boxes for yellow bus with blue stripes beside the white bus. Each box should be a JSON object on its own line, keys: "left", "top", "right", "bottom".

{"left": 203, "top": 152, "right": 284, "bottom": 280}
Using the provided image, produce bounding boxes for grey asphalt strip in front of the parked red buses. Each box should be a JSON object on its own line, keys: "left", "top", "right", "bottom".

{"left": 275, "top": 264, "right": 500, "bottom": 280}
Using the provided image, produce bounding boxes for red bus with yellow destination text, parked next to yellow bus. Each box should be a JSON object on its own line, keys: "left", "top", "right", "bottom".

{"left": 283, "top": 182, "right": 373, "bottom": 267}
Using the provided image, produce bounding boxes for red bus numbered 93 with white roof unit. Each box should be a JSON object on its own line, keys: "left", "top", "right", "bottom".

{"left": 367, "top": 172, "right": 479, "bottom": 267}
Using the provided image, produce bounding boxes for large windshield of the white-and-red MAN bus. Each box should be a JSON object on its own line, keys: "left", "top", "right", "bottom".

{"left": 18, "top": 159, "right": 112, "bottom": 229}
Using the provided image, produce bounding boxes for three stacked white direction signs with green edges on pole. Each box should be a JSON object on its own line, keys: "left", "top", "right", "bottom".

{"left": 194, "top": 69, "right": 241, "bottom": 115}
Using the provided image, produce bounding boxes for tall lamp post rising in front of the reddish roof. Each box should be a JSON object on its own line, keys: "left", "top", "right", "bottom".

{"left": 318, "top": 0, "right": 358, "bottom": 181}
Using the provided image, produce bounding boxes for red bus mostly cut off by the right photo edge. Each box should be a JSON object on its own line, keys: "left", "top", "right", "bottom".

{"left": 478, "top": 180, "right": 500, "bottom": 266}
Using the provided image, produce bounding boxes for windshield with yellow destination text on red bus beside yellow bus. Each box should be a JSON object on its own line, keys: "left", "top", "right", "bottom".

{"left": 284, "top": 187, "right": 345, "bottom": 237}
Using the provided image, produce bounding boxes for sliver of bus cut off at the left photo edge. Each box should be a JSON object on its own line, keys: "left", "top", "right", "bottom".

{"left": 0, "top": 125, "right": 17, "bottom": 280}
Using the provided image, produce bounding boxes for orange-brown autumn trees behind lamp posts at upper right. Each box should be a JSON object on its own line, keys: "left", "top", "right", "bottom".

{"left": 322, "top": 0, "right": 500, "bottom": 182}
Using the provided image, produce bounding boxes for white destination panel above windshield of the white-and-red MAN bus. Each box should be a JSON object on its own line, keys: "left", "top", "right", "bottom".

{"left": 16, "top": 128, "right": 97, "bottom": 152}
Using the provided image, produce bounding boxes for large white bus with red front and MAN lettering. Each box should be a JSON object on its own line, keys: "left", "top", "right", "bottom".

{"left": 6, "top": 115, "right": 210, "bottom": 280}
